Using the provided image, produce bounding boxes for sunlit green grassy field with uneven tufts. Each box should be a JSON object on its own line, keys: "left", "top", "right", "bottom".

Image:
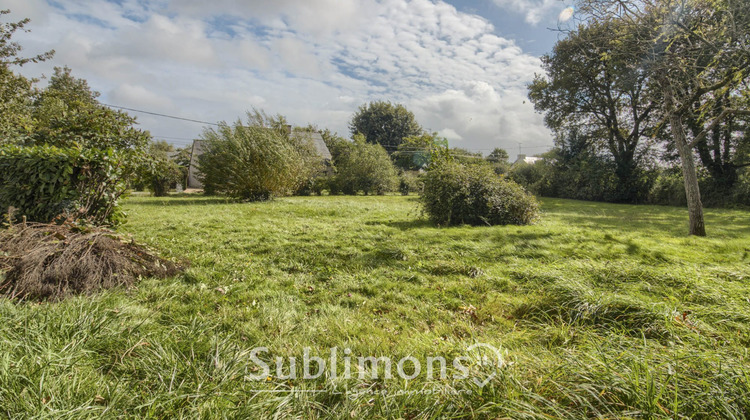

{"left": 0, "top": 196, "right": 750, "bottom": 419}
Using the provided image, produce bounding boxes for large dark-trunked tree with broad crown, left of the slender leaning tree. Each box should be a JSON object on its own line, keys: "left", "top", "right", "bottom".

{"left": 529, "top": 19, "right": 657, "bottom": 202}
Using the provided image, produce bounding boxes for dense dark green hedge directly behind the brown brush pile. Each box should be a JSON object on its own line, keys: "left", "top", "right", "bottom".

{"left": 0, "top": 145, "right": 130, "bottom": 225}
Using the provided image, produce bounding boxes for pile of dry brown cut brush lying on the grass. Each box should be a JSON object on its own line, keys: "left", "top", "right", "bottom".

{"left": 0, "top": 223, "right": 183, "bottom": 300}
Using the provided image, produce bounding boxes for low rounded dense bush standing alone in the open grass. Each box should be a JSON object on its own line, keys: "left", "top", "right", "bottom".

{"left": 421, "top": 162, "right": 539, "bottom": 225}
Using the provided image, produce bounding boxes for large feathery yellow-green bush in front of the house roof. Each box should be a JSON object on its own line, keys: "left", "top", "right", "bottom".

{"left": 199, "top": 118, "right": 314, "bottom": 201}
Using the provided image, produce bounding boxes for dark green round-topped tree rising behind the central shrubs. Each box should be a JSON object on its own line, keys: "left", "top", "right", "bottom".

{"left": 349, "top": 101, "right": 422, "bottom": 154}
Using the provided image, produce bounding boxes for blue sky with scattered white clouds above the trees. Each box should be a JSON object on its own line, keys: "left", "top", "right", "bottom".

{"left": 5, "top": 0, "right": 570, "bottom": 156}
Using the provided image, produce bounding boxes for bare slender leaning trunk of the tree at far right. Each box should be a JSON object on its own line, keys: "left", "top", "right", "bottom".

{"left": 664, "top": 82, "right": 706, "bottom": 236}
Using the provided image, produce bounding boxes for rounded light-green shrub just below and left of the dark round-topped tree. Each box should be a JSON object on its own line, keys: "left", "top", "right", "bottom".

{"left": 331, "top": 136, "right": 398, "bottom": 194}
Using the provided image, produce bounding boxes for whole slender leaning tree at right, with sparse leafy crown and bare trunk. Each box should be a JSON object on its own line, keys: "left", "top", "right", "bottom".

{"left": 579, "top": 0, "right": 750, "bottom": 236}
